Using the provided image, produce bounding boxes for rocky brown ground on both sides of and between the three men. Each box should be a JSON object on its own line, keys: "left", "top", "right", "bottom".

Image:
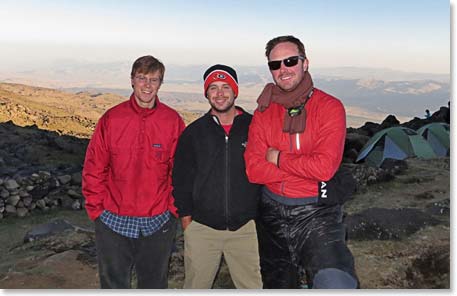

{"left": 0, "top": 158, "right": 450, "bottom": 289}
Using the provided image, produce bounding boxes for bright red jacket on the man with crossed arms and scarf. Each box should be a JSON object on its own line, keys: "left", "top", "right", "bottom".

{"left": 244, "top": 89, "right": 346, "bottom": 198}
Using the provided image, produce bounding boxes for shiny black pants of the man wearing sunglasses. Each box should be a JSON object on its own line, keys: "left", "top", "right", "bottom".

{"left": 257, "top": 196, "right": 358, "bottom": 289}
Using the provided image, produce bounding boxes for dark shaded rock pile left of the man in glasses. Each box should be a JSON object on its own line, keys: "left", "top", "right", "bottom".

{"left": 0, "top": 121, "right": 88, "bottom": 219}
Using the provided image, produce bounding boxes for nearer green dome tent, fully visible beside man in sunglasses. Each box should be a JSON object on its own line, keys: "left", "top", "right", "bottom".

{"left": 356, "top": 126, "right": 437, "bottom": 167}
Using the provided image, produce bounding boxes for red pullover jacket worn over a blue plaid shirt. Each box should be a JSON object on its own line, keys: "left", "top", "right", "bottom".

{"left": 82, "top": 95, "right": 184, "bottom": 220}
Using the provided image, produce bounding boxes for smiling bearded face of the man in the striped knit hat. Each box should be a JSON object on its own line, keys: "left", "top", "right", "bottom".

{"left": 206, "top": 81, "right": 235, "bottom": 114}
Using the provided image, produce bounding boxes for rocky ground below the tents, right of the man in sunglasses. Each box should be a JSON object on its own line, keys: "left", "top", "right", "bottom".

{"left": 345, "top": 158, "right": 450, "bottom": 289}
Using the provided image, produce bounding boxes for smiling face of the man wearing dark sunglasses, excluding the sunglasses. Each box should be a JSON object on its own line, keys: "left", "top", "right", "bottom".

{"left": 268, "top": 42, "right": 308, "bottom": 91}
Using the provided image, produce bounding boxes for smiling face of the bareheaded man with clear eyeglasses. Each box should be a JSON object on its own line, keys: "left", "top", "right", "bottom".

{"left": 131, "top": 70, "right": 162, "bottom": 108}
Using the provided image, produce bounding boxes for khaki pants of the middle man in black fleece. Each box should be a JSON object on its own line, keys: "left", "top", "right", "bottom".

{"left": 183, "top": 220, "right": 262, "bottom": 289}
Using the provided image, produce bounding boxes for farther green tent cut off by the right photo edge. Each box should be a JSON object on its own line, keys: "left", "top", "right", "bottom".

{"left": 417, "top": 122, "right": 450, "bottom": 156}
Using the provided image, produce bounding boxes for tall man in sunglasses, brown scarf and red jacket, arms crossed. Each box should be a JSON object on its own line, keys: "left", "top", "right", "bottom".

{"left": 245, "top": 36, "right": 358, "bottom": 289}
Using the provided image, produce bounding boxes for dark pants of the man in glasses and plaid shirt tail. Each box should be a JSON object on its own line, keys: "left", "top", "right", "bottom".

{"left": 95, "top": 217, "right": 176, "bottom": 289}
